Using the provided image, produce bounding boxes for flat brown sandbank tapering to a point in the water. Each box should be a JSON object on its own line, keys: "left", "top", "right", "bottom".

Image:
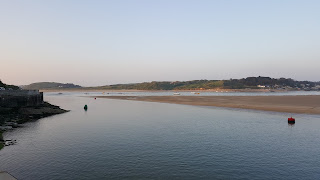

{"left": 95, "top": 95, "right": 320, "bottom": 114}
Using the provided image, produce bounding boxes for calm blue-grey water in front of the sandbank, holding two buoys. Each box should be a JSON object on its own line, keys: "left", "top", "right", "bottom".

{"left": 0, "top": 94, "right": 320, "bottom": 180}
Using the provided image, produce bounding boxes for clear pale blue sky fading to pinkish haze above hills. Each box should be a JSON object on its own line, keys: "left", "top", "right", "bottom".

{"left": 0, "top": 0, "right": 320, "bottom": 86}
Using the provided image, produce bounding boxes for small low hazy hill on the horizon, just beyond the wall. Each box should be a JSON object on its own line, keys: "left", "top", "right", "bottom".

{"left": 22, "top": 82, "right": 81, "bottom": 90}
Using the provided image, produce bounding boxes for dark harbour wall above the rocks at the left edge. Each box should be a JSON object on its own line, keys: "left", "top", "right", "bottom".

{"left": 0, "top": 90, "right": 43, "bottom": 108}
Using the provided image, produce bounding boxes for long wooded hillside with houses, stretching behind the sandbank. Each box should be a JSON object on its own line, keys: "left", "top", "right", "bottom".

{"left": 87, "top": 76, "right": 320, "bottom": 90}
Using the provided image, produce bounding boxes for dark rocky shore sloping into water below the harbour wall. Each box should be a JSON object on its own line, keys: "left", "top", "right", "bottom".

{"left": 0, "top": 102, "right": 68, "bottom": 150}
